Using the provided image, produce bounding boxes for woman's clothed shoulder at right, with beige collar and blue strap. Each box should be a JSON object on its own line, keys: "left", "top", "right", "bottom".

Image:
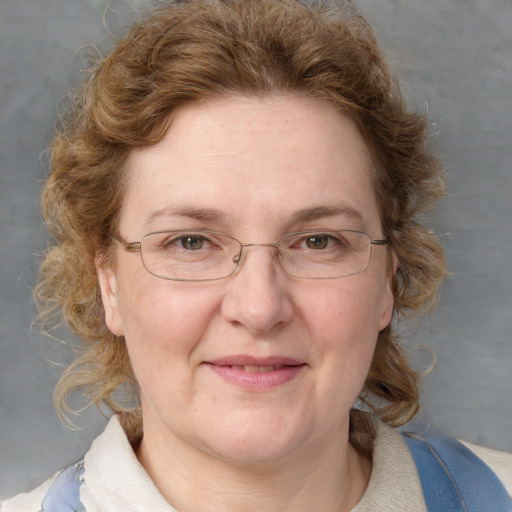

{"left": 356, "top": 414, "right": 512, "bottom": 512}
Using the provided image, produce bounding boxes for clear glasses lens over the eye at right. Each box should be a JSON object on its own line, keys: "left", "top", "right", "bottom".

{"left": 279, "top": 231, "right": 371, "bottom": 279}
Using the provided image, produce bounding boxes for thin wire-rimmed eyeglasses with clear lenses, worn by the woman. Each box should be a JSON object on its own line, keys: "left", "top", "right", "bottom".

{"left": 114, "top": 229, "right": 388, "bottom": 281}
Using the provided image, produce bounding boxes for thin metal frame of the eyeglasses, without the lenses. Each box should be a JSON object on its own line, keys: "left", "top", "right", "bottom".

{"left": 112, "top": 229, "right": 389, "bottom": 283}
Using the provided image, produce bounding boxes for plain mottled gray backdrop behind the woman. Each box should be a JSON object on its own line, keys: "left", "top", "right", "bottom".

{"left": 0, "top": 0, "right": 512, "bottom": 497}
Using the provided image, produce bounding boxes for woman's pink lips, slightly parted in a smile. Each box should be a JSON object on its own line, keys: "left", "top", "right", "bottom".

{"left": 204, "top": 355, "right": 307, "bottom": 392}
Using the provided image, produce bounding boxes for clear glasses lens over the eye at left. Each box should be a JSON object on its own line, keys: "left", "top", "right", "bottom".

{"left": 141, "top": 230, "right": 240, "bottom": 281}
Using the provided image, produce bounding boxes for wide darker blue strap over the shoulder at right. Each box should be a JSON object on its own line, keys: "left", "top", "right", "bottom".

{"left": 404, "top": 433, "right": 512, "bottom": 512}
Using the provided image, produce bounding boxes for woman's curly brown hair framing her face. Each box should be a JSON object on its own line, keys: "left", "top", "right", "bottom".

{"left": 36, "top": 0, "right": 445, "bottom": 429}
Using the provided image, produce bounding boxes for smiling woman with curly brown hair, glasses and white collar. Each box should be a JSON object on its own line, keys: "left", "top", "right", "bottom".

{"left": 3, "top": 0, "right": 511, "bottom": 512}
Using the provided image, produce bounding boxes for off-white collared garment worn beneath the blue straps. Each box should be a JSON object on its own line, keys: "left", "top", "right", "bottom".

{"left": 0, "top": 415, "right": 512, "bottom": 512}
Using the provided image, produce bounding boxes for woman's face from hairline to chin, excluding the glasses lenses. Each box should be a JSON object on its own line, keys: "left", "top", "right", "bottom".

{"left": 100, "top": 97, "right": 393, "bottom": 463}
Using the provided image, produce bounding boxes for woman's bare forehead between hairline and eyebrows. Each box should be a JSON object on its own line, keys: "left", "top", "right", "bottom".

{"left": 121, "top": 97, "right": 378, "bottom": 234}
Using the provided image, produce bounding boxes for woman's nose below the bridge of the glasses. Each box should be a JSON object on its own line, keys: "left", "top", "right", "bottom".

{"left": 221, "top": 244, "right": 294, "bottom": 333}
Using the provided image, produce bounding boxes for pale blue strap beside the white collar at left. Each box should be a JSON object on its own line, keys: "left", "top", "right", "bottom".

{"left": 41, "top": 461, "right": 85, "bottom": 512}
